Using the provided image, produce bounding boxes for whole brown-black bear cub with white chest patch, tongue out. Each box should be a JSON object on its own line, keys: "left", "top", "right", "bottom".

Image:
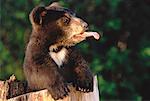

{"left": 23, "top": 4, "right": 99, "bottom": 100}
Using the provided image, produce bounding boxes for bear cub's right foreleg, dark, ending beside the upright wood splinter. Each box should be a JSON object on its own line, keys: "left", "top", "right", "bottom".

{"left": 71, "top": 51, "right": 93, "bottom": 92}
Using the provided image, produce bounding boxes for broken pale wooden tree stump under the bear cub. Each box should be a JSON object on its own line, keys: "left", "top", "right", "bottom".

{"left": 0, "top": 75, "right": 99, "bottom": 101}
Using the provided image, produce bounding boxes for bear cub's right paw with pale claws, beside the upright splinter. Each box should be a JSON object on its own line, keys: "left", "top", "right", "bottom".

{"left": 73, "top": 78, "right": 93, "bottom": 93}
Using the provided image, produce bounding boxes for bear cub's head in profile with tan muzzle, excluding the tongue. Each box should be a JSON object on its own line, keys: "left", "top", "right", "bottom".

{"left": 30, "top": 3, "right": 88, "bottom": 44}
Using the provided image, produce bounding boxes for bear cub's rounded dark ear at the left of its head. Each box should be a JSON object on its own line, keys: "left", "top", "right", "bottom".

{"left": 30, "top": 7, "right": 47, "bottom": 25}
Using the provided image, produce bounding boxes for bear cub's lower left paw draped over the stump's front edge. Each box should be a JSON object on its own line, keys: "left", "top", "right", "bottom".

{"left": 49, "top": 83, "right": 70, "bottom": 100}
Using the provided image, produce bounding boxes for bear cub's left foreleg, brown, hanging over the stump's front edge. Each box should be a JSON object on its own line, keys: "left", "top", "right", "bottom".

{"left": 45, "top": 62, "right": 69, "bottom": 100}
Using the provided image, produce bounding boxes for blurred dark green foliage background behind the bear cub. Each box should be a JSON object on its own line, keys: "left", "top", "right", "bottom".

{"left": 0, "top": 0, "right": 150, "bottom": 101}
